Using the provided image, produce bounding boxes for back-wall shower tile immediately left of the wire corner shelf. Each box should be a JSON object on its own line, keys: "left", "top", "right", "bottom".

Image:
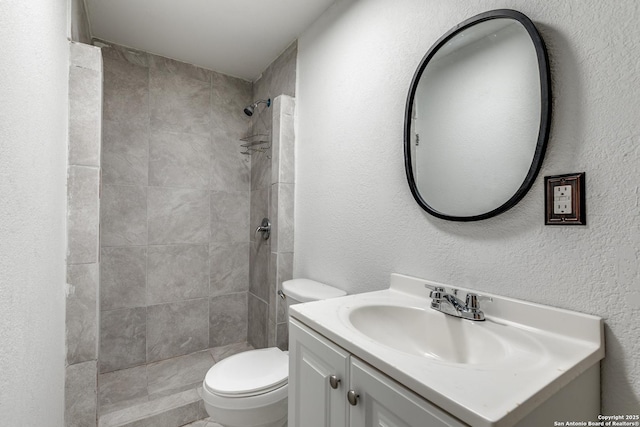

{"left": 210, "top": 133, "right": 251, "bottom": 191}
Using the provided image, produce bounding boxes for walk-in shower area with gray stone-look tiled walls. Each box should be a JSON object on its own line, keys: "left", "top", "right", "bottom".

{"left": 67, "top": 41, "right": 297, "bottom": 425}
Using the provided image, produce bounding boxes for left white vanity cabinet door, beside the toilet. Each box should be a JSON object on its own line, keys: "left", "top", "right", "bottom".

{"left": 289, "top": 319, "right": 349, "bottom": 427}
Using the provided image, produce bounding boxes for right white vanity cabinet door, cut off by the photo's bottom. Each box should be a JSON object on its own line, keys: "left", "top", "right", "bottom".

{"left": 349, "top": 357, "right": 466, "bottom": 427}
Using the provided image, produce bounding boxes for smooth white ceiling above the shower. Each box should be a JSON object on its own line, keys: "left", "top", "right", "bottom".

{"left": 85, "top": 0, "right": 335, "bottom": 80}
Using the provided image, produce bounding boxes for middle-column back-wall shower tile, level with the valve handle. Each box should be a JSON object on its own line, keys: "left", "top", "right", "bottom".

{"left": 148, "top": 187, "right": 210, "bottom": 244}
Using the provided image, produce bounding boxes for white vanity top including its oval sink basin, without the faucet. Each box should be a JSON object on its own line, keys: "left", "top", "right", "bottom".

{"left": 289, "top": 274, "right": 604, "bottom": 427}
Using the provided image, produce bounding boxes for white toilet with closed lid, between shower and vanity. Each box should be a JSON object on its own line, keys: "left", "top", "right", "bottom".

{"left": 202, "top": 279, "right": 346, "bottom": 427}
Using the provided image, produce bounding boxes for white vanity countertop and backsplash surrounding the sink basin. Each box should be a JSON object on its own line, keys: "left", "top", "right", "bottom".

{"left": 289, "top": 274, "right": 604, "bottom": 427}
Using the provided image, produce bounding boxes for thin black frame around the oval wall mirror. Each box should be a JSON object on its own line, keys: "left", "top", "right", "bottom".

{"left": 404, "top": 9, "right": 551, "bottom": 221}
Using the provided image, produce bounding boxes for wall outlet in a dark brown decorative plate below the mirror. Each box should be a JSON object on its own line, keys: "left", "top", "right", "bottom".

{"left": 544, "top": 172, "right": 587, "bottom": 225}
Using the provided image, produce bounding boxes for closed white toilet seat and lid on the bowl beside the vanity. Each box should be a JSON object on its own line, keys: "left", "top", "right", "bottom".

{"left": 204, "top": 347, "right": 289, "bottom": 398}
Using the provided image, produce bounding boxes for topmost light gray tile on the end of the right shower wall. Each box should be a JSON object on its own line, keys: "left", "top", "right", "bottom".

{"left": 271, "top": 95, "right": 295, "bottom": 184}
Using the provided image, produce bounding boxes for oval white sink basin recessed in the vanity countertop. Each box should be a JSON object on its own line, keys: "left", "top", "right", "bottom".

{"left": 348, "top": 305, "right": 508, "bottom": 364}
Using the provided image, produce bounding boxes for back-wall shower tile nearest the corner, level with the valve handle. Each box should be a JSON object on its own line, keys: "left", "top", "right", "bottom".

{"left": 211, "top": 191, "right": 250, "bottom": 243}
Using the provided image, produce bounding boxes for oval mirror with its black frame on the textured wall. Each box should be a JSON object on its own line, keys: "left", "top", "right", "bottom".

{"left": 404, "top": 9, "right": 551, "bottom": 221}
